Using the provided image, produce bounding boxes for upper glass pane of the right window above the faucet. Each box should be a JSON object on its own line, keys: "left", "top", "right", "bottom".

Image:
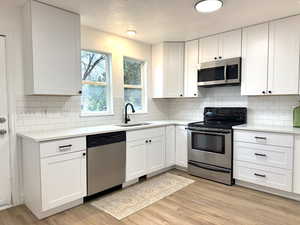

{"left": 124, "top": 58, "right": 143, "bottom": 85}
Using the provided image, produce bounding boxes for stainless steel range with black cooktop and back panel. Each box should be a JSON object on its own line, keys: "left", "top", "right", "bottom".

{"left": 188, "top": 107, "right": 247, "bottom": 185}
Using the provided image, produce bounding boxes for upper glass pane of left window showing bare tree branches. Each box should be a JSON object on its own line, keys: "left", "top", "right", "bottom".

{"left": 81, "top": 50, "right": 108, "bottom": 82}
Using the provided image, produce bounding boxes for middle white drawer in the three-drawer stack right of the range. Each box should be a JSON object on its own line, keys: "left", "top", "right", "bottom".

{"left": 234, "top": 142, "right": 293, "bottom": 169}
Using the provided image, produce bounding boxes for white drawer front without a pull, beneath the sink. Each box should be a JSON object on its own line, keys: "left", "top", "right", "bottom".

{"left": 126, "top": 127, "right": 165, "bottom": 142}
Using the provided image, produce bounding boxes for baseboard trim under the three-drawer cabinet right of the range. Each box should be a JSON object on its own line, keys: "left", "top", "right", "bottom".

{"left": 235, "top": 179, "right": 300, "bottom": 201}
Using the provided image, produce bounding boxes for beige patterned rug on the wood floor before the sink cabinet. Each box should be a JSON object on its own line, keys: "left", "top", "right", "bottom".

{"left": 91, "top": 173, "right": 194, "bottom": 220}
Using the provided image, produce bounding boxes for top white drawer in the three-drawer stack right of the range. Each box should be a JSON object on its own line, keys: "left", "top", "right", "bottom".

{"left": 234, "top": 131, "right": 294, "bottom": 147}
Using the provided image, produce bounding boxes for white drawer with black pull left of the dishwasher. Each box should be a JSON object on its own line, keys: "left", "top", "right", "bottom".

{"left": 40, "top": 137, "right": 86, "bottom": 158}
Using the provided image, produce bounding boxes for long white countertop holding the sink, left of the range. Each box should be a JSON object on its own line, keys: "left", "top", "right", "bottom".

{"left": 17, "top": 120, "right": 194, "bottom": 142}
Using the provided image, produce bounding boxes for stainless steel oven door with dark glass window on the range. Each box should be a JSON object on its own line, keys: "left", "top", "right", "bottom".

{"left": 188, "top": 129, "right": 232, "bottom": 169}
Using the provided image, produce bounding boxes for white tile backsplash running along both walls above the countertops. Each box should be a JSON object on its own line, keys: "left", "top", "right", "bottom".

{"left": 16, "top": 86, "right": 300, "bottom": 131}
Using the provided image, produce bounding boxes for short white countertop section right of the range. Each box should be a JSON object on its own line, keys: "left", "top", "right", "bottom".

{"left": 233, "top": 124, "right": 300, "bottom": 134}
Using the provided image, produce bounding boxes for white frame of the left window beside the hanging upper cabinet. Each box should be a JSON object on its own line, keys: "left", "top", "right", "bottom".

{"left": 80, "top": 48, "right": 114, "bottom": 117}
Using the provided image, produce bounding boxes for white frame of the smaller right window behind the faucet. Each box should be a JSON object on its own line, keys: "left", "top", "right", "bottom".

{"left": 122, "top": 56, "right": 148, "bottom": 114}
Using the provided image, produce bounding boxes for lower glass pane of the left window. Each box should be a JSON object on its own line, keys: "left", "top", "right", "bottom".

{"left": 81, "top": 84, "right": 108, "bottom": 112}
